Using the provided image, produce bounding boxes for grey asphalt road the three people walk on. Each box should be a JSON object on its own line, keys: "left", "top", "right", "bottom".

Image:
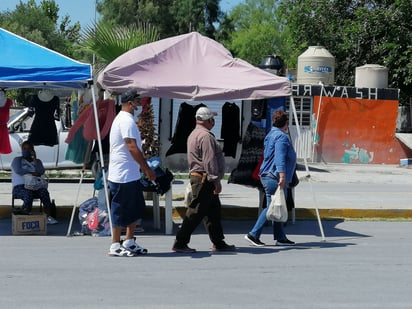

{"left": 0, "top": 219, "right": 412, "bottom": 309}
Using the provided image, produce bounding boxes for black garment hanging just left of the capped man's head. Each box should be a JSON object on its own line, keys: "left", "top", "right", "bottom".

{"left": 166, "top": 102, "right": 206, "bottom": 157}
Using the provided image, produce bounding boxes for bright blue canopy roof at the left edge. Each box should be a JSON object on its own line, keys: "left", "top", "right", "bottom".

{"left": 0, "top": 28, "right": 92, "bottom": 89}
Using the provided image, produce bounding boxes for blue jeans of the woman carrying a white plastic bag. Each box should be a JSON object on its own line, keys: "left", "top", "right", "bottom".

{"left": 249, "top": 176, "right": 286, "bottom": 240}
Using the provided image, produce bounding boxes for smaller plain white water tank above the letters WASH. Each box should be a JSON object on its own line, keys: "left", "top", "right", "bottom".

{"left": 355, "top": 64, "right": 388, "bottom": 88}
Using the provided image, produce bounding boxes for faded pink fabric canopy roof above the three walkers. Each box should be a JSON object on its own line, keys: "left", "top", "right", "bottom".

{"left": 97, "top": 32, "right": 291, "bottom": 101}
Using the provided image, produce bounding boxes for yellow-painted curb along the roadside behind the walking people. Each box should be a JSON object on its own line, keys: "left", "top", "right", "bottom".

{"left": 0, "top": 206, "right": 412, "bottom": 221}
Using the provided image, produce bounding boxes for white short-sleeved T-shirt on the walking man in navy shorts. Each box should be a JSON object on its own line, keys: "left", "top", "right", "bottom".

{"left": 108, "top": 111, "right": 142, "bottom": 183}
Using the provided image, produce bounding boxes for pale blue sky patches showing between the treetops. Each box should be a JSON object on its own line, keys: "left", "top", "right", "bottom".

{"left": 0, "top": 0, "right": 244, "bottom": 28}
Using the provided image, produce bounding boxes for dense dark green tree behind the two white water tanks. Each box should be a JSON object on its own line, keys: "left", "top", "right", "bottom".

{"left": 279, "top": 0, "right": 412, "bottom": 101}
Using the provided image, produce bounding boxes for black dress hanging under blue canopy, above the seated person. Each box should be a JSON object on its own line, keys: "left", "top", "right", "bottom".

{"left": 28, "top": 95, "right": 60, "bottom": 146}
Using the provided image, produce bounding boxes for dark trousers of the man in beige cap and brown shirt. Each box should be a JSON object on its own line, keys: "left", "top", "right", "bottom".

{"left": 175, "top": 176, "right": 225, "bottom": 246}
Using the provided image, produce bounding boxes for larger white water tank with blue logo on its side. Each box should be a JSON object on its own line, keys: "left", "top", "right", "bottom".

{"left": 297, "top": 46, "right": 335, "bottom": 86}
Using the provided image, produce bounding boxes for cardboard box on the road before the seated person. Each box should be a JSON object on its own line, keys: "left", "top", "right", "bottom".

{"left": 11, "top": 213, "right": 47, "bottom": 235}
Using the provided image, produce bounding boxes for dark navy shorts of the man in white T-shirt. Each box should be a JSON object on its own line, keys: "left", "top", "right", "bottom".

{"left": 109, "top": 180, "right": 146, "bottom": 227}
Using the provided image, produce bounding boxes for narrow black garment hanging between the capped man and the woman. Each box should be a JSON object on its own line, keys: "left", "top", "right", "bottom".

{"left": 220, "top": 102, "right": 241, "bottom": 158}
